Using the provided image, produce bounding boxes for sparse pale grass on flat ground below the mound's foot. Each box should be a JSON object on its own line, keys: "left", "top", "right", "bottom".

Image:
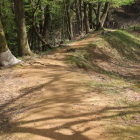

{"left": 86, "top": 77, "right": 140, "bottom": 96}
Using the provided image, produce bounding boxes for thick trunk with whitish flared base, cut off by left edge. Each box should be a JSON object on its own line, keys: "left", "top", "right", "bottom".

{"left": 0, "top": 17, "right": 21, "bottom": 66}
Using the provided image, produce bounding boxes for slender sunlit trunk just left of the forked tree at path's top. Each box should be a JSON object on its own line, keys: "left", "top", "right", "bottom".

{"left": 84, "top": 2, "right": 90, "bottom": 34}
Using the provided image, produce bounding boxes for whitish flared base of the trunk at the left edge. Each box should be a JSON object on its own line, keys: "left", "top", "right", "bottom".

{"left": 0, "top": 49, "right": 21, "bottom": 66}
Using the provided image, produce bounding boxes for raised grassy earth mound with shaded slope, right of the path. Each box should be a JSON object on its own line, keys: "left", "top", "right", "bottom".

{"left": 69, "top": 31, "right": 140, "bottom": 80}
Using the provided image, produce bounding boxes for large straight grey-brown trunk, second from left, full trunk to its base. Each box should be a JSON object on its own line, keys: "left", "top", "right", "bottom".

{"left": 14, "top": 0, "right": 33, "bottom": 56}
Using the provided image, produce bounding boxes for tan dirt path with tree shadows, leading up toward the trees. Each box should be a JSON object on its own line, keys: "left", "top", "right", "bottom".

{"left": 0, "top": 33, "right": 140, "bottom": 140}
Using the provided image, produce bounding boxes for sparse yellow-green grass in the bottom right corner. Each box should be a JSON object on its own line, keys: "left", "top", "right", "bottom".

{"left": 107, "top": 104, "right": 140, "bottom": 140}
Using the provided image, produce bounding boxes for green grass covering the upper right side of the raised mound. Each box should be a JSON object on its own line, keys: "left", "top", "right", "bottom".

{"left": 103, "top": 30, "right": 140, "bottom": 61}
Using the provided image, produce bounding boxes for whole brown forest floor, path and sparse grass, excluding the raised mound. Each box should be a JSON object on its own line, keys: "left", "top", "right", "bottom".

{"left": 0, "top": 34, "right": 140, "bottom": 140}
